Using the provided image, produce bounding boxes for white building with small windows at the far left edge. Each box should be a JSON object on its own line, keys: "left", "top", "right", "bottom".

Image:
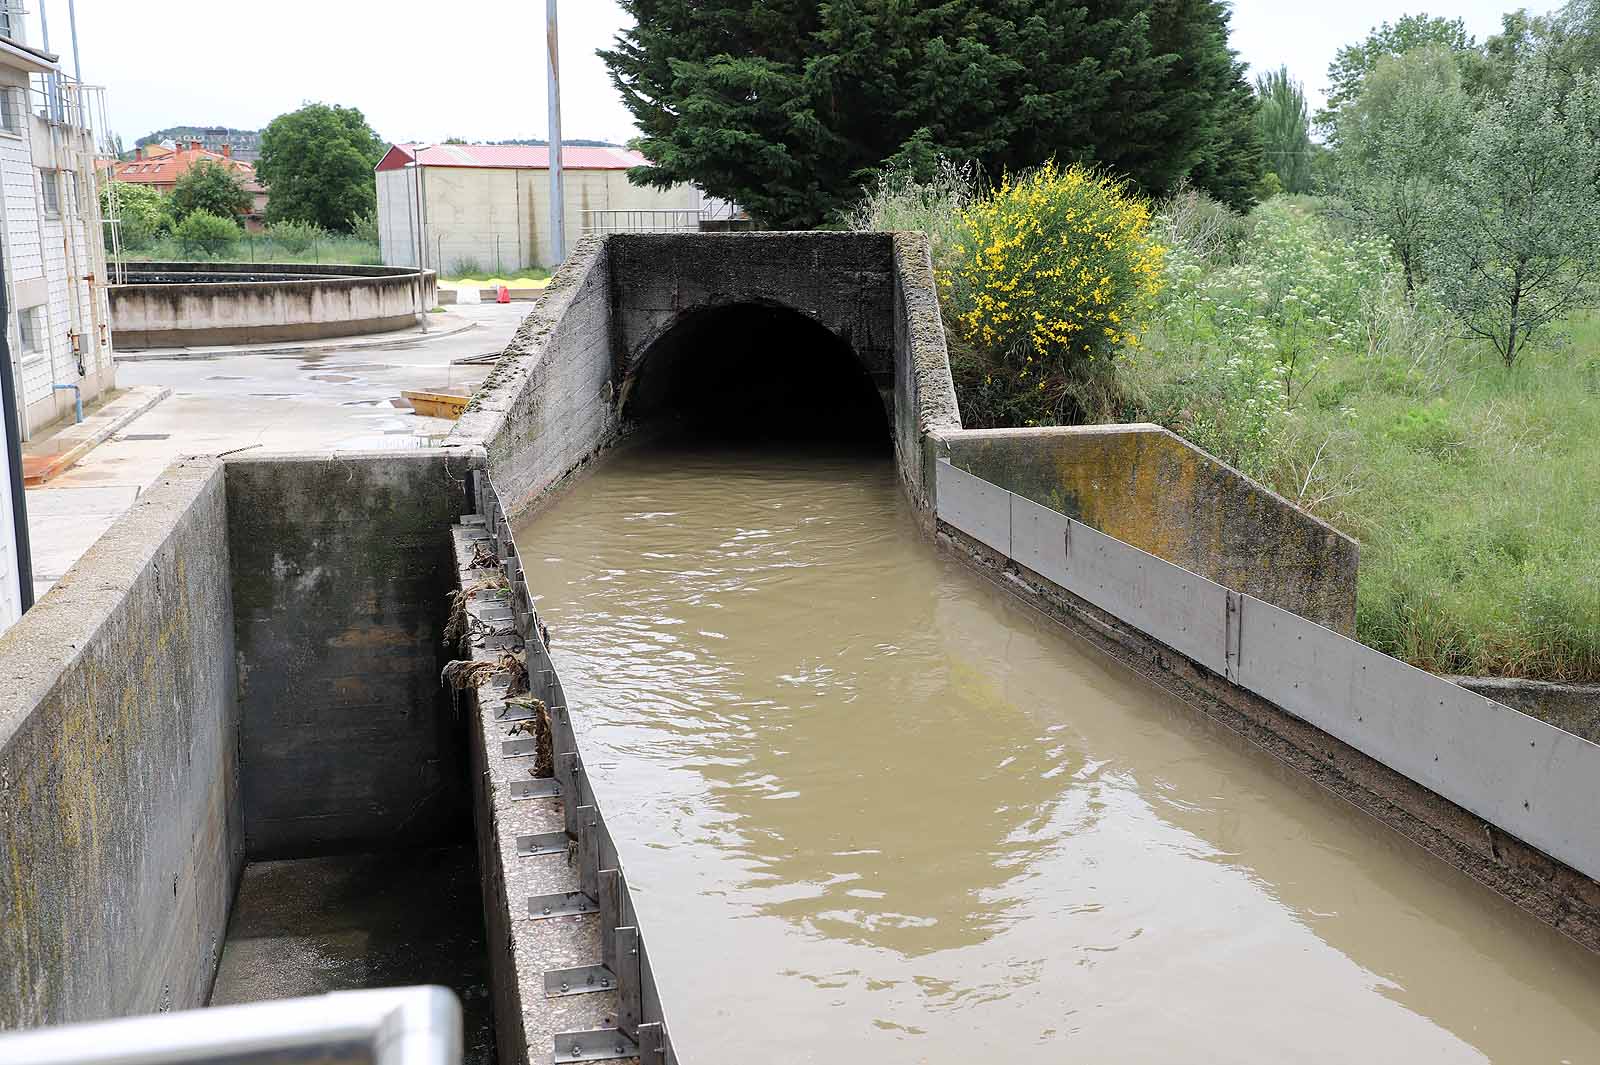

{"left": 0, "top": 8, "right": 115, "bottom": 627}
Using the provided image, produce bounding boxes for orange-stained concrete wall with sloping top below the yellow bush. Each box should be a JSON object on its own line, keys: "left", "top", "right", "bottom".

{"left": 938, "top": 425, "right": 1360, "bottom": 635}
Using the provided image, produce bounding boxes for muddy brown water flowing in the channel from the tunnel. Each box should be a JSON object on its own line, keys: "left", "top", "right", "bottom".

{"left": 517, "top": 448, "right": 1600, "bottom": 1065}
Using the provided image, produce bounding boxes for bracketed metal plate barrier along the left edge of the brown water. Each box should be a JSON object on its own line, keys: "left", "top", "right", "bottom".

{"left": 472, "top": 470, "right": 677, "bottom": 1065}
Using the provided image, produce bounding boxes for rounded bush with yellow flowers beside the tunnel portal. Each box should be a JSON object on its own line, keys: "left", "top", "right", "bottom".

{"left": 939, "top": 163, "right": 1166, "bottom": 425}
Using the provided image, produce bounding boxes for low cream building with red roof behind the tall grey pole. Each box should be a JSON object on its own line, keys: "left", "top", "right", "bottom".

{"left": 376, "top": 144, "right": 730, "bottom": 273}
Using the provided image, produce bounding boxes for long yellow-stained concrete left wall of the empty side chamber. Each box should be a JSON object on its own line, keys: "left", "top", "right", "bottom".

{"left": 0, "top": 461, "right": 243, "bottom": 1028}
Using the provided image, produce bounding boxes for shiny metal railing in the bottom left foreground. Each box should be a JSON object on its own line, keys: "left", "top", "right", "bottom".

{"left": 0, "top": 987, "right": 461, "bottom": 1065}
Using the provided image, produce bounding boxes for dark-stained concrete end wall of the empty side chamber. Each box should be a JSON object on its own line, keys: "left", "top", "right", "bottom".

{"left": 227, "top": 451, "right": 474, "bottom": 857}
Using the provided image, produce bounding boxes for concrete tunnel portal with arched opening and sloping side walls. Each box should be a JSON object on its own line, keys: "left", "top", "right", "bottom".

{"left": 453, "top": 233, "right": 962, "bottom": 510}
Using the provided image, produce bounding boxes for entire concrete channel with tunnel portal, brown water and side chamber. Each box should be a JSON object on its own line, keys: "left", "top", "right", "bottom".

{"left": 0, "top": 233, "right": 1600, "bottom": 1065}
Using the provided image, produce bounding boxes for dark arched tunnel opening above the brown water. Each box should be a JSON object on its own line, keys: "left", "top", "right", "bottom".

{"left": 622, "top": 304, "right": 893, "bottom": 449}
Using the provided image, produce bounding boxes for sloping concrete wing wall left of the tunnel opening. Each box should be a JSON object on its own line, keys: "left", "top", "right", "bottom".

{"left": 445, "top": 237, "right": 621, "bottom": 513}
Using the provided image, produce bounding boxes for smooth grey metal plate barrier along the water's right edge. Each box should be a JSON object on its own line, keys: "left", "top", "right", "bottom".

{"left": 936, "top": 459, "right": 1600, "bottom": 880}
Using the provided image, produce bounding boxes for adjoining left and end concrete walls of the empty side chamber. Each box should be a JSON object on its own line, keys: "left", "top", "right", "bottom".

{"left": 0, "top": 451, "right": 482, "bottom": 1028}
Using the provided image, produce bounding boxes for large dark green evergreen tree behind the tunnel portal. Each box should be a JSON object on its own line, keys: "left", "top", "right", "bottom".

{"left": 602, "top": 0, "right": 1259, "bottom": 227}
